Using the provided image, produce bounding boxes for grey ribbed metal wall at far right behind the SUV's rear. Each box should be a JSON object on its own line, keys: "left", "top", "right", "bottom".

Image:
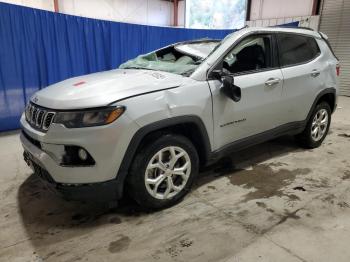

{"left": 320, "top": 0, "right": 350, "bottom": 96}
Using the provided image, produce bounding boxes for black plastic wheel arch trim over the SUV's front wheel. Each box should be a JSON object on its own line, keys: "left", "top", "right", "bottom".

{"left": 116, "top": 115, "right": 211, "bottom": 198}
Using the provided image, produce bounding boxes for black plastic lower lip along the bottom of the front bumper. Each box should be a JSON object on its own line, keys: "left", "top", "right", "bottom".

{"left": 23, "top": 151, "right": 121, "bottom": 202}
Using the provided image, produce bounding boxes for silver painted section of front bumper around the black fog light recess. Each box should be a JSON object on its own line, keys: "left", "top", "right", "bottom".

{"left": 20, "top": 115, "right": 136, "bottom": 184}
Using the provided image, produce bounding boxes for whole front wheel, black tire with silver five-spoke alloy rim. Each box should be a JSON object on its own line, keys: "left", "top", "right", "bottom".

{"left": 128, "top": 134, "right": 199, "bottom": 209}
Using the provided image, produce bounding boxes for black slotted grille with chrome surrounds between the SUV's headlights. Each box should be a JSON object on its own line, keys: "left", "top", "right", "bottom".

{"left": 25, "top": 103, "right": 55, "bottom": 132}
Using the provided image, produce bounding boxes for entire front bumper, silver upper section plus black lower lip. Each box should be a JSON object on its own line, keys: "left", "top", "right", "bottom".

{"left": 20, "top": 110, "right": 138, "bottom": 200}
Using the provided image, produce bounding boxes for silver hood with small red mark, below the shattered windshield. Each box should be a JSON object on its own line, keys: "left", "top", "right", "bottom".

{"left": 31, "top": 69, "right": 184, "bottom": 109}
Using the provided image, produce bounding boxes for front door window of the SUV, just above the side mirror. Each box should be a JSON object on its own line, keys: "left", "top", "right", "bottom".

{"left": 223, "top": 35, "right": 272, "bottom": 74}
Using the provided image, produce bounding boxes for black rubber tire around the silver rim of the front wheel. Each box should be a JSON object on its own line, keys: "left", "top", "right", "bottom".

{"left": 127, "top": 134, "right": 199, "bottom": 210}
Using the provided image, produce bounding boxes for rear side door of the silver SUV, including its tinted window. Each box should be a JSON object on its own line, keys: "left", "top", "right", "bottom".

{"left": 277, "top": 33, "right": 328, "bottom": 123}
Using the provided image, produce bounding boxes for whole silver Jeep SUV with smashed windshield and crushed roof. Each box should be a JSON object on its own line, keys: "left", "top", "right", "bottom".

{"left": 21, "top": 28, "right": 339, "bottom": 208}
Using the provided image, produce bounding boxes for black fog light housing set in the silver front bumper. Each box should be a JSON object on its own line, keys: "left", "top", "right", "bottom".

{"left": 61, "top": 146, "right": 95, "bottom": 166}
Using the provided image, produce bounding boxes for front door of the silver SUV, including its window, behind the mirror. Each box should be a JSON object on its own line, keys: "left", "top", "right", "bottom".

{"left": 208, "top": 34, "right": 283, "bottom": 150}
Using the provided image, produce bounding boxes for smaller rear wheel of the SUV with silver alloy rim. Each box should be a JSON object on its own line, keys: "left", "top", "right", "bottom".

{"left": 297, "top": 102, "right": 331, "bottom": 148}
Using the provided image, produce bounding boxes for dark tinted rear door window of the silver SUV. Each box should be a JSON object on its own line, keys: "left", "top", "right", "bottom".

{"left": 277, "top": 34, "right": 320, "bottom": 66}
